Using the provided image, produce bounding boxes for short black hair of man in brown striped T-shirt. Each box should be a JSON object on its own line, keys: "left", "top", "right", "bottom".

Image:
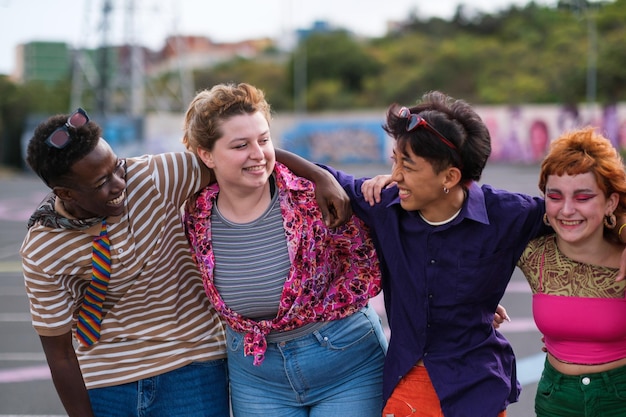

{"left": 26, "top": 114, "right": 102, "bottom": 188}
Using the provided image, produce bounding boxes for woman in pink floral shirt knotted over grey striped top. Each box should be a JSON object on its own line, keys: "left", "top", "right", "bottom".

{"left": 183, "top": 83, "right": 387, "bottom": 417}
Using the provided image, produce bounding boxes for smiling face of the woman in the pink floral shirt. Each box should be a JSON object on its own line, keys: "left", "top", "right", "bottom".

{"left": 198, "top": 112, "right": 276, "bottom": 195}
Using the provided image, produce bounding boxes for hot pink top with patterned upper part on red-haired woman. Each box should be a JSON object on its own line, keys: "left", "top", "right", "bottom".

{"left": 518, "top": 235, "right": 626, "bottom": 365}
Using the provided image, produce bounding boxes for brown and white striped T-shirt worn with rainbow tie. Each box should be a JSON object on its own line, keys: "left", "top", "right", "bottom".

{"left": 20, "top": 152, "right": 226, "bottom": 389}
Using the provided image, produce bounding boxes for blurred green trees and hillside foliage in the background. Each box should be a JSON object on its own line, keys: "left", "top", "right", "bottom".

{"left": 0, "top": 0, "right": 626, "bottom": 166}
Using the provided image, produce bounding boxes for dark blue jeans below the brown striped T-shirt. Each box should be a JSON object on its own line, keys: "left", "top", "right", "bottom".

{"left": 89, "top": 359, "right": 225, "bottom": 417}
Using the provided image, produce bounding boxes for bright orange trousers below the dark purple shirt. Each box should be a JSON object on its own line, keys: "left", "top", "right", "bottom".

{"left": 383, "top": 366, "right": 506, "bottom": 417}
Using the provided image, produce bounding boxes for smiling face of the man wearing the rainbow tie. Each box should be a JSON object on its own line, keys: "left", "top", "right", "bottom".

{"left": 54, "top": 140, "right": 126, "bottom": 219}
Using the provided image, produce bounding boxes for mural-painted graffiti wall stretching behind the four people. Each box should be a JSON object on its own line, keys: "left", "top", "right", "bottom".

{"left": 95, "top": 103, "right": 626, "bottom": 165}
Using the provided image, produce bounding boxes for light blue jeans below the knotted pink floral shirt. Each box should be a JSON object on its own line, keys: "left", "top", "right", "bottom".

{"left": 226, "top": 306, "right": 387, "bottom": 417}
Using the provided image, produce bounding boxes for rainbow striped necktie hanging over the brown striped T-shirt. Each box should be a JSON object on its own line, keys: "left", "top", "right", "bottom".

{"left": 76, "top": 220, "right": 111, "bottom": 346}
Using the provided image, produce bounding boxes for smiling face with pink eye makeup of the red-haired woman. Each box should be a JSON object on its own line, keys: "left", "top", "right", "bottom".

{"left": 545, "top": 172, "right": 618, "bottom": 246}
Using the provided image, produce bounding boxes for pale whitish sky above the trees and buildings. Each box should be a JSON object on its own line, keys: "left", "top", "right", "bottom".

{"left": 0, "top": 0, "right": 555, "bottom": 74}
